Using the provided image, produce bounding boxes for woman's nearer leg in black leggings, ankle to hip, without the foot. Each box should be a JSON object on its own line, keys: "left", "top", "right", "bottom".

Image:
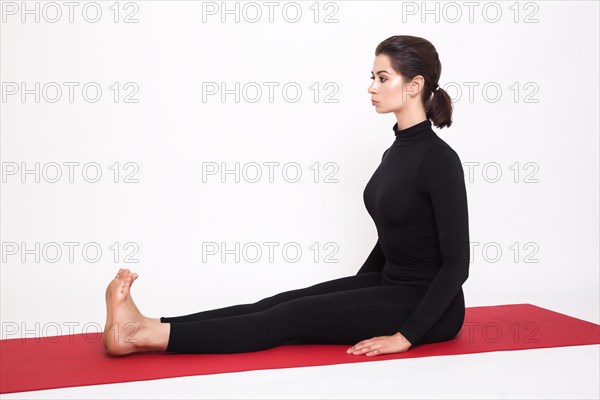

{"left": 166, "top": 286, "right": 436, "bottom": 353}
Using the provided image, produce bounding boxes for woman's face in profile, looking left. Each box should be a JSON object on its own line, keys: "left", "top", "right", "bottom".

{"left": 368, "top": 54, "right": 418, "bottom": 113}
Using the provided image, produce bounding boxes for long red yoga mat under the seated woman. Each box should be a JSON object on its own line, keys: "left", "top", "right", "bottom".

{"left": 0, "top": 304, "right": 600, "bottom": 393}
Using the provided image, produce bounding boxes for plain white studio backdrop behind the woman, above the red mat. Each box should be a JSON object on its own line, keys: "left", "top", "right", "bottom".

{"left": 0, "top": 1, "right": 600, "bottom": 396}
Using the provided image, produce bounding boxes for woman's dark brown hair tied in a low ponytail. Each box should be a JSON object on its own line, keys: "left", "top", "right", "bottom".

{"left": 375, "top": 35, "right": 452, "bottom": 128}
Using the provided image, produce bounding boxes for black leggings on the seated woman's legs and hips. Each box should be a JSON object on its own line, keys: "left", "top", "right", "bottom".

{"left": 160, "top": 272, "right": 465, "bottom": 353}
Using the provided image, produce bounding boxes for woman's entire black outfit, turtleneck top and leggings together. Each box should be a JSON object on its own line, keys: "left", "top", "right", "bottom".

{"left": 160, "top": 119, "right": 470, "bottom": 353}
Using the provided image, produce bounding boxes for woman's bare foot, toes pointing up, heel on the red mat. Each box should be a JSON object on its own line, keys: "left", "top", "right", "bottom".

{"left": 102, "top": 268, "right": 156, "bottom": 356}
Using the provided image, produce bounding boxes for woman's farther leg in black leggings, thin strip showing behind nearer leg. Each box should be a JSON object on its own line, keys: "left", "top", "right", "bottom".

{"left": 160, "top": 272, "right": 381, "bottom": 322}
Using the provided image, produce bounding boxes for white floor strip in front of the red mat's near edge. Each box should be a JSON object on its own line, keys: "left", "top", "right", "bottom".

{"left": 1, "top": 345, "right": 600, "bottom": 399}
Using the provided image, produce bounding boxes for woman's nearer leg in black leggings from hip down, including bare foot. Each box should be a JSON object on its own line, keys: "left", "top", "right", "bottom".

{"left": 103, "top": 269, "right": 464, "bottom": 355}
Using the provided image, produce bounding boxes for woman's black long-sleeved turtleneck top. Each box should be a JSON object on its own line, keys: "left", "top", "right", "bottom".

{"left": 357, "top": 119, "right": 470, "bottom": 345}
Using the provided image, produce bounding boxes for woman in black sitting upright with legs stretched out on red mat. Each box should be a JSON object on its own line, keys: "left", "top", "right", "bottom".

{"left": 103, "top": 36, "right": 469, "bottom": 356}
